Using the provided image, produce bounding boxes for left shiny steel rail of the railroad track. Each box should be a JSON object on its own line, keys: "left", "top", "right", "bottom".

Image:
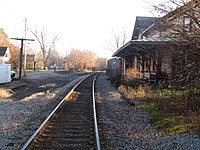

{"left": 21, "top": 74, "right": 92, "bottom": 150}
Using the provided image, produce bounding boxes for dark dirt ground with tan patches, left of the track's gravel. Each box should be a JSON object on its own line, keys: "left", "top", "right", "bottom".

{"left": 0, "top": 71, "right": 85, "bottom": 101}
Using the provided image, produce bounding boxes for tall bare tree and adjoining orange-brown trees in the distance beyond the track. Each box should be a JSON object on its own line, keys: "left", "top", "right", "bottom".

{"left": 31, "top": 28, "right": 106, "bottom": 70}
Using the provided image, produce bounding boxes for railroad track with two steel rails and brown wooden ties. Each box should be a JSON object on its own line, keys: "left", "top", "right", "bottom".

{"left": 21, "top": 73, "right": 100, "bottom": 150}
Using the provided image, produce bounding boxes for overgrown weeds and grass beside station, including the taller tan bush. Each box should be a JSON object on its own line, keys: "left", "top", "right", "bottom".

{"left": 118, "top": 69, "right": 200, "bottom": 134}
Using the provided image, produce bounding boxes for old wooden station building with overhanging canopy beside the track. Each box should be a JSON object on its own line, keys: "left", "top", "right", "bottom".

{"left": 113, "top": 1, "right": 199, "bottom": 79}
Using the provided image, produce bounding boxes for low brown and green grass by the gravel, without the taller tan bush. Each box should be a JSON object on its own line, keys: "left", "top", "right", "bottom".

{"left": 119, "top": 86, "right": 200, "bottom": 134}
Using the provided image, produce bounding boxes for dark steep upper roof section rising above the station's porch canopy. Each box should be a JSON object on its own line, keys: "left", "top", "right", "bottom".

{"left": 131, "top": 16, "right": 158, "bottom": 40}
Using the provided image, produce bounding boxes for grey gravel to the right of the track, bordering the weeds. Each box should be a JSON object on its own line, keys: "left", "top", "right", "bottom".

{"left": 96, "top": 74, "right": 200, "bottom": 150}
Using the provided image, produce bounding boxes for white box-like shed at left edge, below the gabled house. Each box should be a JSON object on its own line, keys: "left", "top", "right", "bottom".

{"left": 0, "top": 64, "right": 11, "bottom": 84}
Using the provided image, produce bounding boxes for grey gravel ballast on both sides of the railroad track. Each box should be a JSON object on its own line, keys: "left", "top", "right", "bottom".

{"left": 0, "top": 73, "right": 200, "bottom": 150}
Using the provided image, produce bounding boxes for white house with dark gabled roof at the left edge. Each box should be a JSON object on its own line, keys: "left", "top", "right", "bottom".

{"left": 0, "top": 47, "right": 11, "bottom": 64}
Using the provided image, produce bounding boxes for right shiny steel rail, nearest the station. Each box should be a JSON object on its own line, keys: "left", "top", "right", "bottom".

{"left": 92, "top": 73, "right": 101, "bottom": 150}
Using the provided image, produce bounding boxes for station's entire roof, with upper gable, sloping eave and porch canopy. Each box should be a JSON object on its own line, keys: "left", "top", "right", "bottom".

{"left": 112, "top": 0, "right": 199, "bottom": 57}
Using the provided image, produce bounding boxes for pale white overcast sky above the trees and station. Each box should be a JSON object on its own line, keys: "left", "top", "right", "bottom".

{"left": 0, "top": 0, "right": 160, "bottom": 57}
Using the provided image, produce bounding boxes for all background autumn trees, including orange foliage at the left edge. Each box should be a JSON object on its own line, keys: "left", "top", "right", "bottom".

{"left": 0, "top": 28, "right": 107, "bottom": 70}
